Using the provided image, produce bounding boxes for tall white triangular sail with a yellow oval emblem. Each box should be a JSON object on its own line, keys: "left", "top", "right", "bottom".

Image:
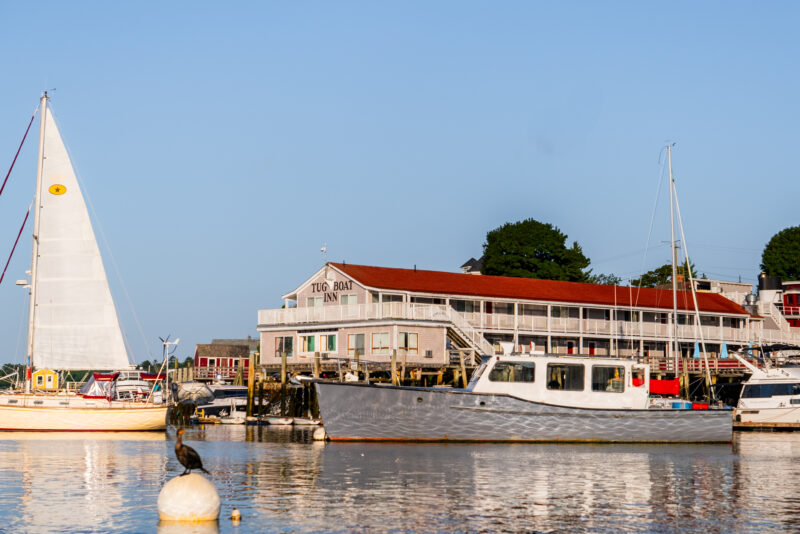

{"left": 30, "top": 100, "right": 129, "bottom": 370}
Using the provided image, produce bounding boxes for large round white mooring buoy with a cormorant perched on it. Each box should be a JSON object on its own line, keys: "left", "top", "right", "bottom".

{"left": 158, "top": 473, "right": 220, "bottom": 522}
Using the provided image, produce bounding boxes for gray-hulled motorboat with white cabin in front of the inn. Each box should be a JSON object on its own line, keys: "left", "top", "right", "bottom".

{"left": 314, "top": 355, "right": 732, "bottom": 442}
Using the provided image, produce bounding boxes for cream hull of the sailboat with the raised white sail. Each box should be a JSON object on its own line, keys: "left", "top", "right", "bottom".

{"left": 0, "top": 395, "right": 167, "bottom": 432}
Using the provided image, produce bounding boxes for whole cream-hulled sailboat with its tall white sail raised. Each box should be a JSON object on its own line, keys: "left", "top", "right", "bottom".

{"left": 0, "top": 93, "right": 167, "bottom": 431}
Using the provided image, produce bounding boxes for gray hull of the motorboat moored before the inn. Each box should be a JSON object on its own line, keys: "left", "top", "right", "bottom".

{"left": 315, "top": 381, "right": 733, "bottom": 443}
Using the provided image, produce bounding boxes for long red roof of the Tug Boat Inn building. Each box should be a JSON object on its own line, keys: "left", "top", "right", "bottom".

{"left": 331, "top": 263, "right": 748, "bottom": 315}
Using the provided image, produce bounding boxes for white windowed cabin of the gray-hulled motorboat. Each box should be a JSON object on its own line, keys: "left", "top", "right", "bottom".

{"left": 468, "top": 355, "right": 650, "bottom": 410}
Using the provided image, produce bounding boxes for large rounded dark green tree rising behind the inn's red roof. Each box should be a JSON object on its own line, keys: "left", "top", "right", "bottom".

{"left": 481, "top": 219, "right": 591, "bottom": 282}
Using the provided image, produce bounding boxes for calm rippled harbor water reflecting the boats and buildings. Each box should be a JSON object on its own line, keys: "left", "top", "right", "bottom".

{"left": 0, "top": 425, "right": 800, "bottom": 533}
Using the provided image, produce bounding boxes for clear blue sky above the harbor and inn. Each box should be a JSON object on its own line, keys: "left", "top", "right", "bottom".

{"left": 0, "top": 0, "right": 800, "bottom": 361}
